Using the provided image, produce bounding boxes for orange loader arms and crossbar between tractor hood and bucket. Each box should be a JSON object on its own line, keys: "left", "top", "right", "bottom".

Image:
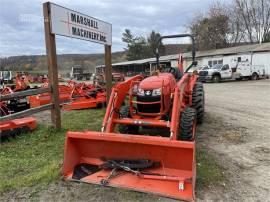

{"left": 101, "top": 74, "right": 198, "bottom": 140}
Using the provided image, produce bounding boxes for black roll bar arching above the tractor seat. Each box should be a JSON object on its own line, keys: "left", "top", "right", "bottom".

{"left": 156, "top": 34, "right": 197, "bottom": 72}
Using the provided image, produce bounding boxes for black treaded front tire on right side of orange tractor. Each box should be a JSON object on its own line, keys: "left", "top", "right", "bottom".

{"left": 177, "top": 107, "right": 196, "bottom": 141}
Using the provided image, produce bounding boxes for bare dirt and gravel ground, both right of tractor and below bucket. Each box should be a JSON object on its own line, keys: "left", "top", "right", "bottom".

{"left": 0, "top": 80, "right": 270, "bottom": 201}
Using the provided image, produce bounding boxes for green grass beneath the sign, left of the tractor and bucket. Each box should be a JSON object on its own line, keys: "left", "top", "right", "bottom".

{"left": 0, "top": 110, "right": 104, "bottom": 193}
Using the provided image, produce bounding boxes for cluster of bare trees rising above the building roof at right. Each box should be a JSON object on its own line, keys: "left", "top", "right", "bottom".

{"left": 189, "top": 0, "right": 270, "bottom": 50}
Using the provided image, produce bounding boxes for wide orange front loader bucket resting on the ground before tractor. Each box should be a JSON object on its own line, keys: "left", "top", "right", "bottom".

{"left": 62, "top": 131, "right": 196, "bottom": 201}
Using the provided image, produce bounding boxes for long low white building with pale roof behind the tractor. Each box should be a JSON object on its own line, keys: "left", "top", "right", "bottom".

{"left": 96, "top": 43, "right": 270, "bottom": 76}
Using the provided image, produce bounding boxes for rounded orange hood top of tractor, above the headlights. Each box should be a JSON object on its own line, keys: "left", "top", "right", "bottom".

{"left": 139, "top": 73, "right": 176, "bottom": 90}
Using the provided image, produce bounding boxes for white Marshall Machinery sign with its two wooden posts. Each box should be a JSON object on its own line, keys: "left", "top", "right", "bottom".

{"left": 43, "top": 2, "right": 112, "bottom": 129}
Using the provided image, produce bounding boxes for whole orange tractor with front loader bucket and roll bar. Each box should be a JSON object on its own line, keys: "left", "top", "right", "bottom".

{"left": 62, "top": 34, "right": 204, "bottom": 201}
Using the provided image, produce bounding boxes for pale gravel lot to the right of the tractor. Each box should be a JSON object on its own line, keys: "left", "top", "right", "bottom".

{"left": 198, "top": 80, "right": 270, "bottom": 201}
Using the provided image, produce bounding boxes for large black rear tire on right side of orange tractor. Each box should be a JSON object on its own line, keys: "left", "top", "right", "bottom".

{"left": 191, "top": 82, "right": 204, "bottom": 124}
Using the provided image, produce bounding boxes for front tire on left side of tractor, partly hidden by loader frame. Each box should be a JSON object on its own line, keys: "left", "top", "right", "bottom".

{"left": 118, "top": 105, "right": 139, "bottom": 134}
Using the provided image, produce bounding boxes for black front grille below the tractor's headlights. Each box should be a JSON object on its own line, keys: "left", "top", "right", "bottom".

{"left": 137, "top": 95, "right": 160, "bottom": 113}
